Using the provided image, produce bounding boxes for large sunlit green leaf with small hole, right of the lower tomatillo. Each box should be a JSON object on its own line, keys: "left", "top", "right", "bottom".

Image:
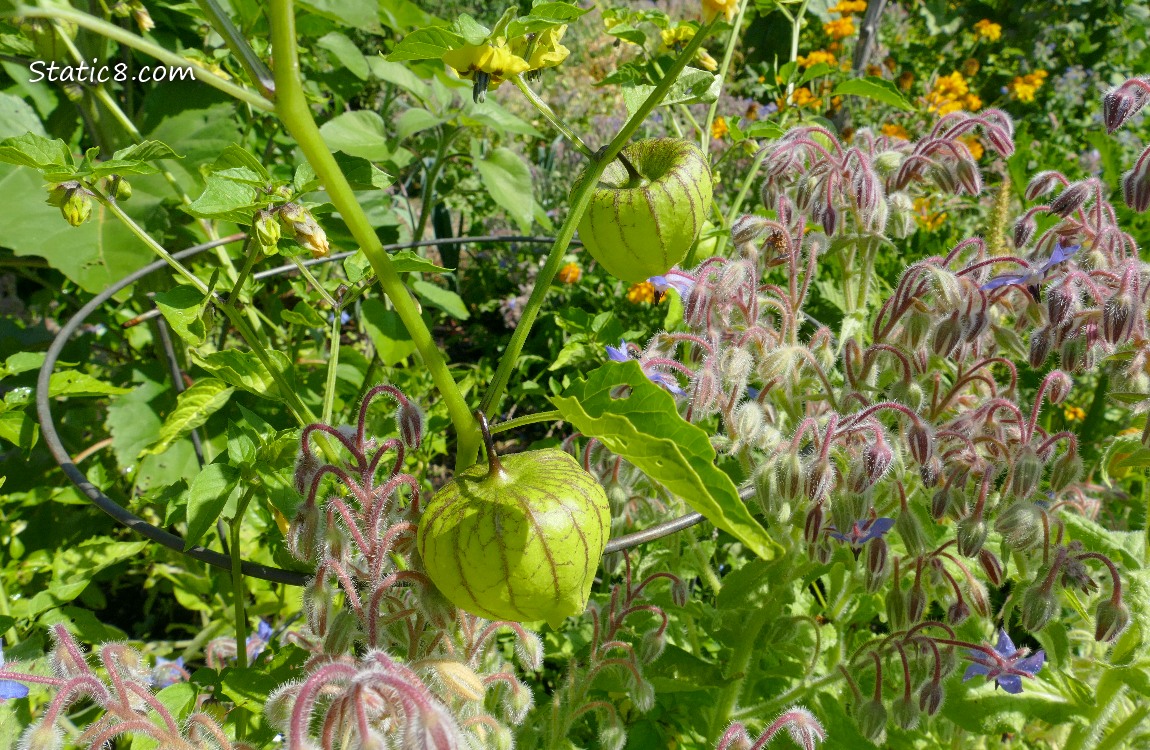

{"left": 551, "top": 361, "right": 775, "bottom": 559}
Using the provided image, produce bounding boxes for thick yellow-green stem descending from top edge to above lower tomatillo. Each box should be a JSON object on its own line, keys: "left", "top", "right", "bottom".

{"left": 267, "top": 0, "right": 480, "bottom": 469}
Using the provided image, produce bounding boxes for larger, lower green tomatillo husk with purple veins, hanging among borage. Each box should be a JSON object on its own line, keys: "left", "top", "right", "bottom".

{"left": 416, "top": 420, "right": 611, "bottom": 627}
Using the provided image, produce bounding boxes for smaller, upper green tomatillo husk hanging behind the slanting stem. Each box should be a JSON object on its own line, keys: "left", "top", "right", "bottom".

{"left": 575, "top": 138, "right": 712, "bottom": 282}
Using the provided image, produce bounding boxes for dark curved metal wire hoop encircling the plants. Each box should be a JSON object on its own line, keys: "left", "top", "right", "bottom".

{"left": 36, "top": 236, "right": 703, "bottom": 586}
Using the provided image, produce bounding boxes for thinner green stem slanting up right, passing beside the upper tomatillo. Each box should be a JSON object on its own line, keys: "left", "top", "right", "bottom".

{"left": 481, "top": 22, "right": 713, "bottom": 418}
